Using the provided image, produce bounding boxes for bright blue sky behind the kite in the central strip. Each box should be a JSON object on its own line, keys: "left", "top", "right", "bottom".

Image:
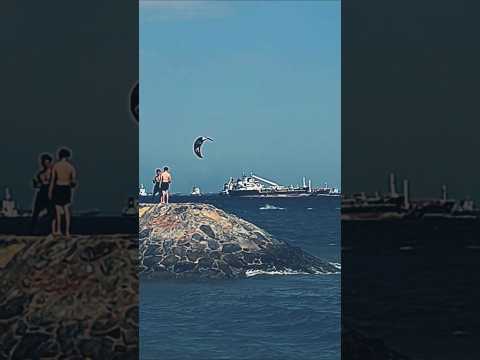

{"left": 140, "top": 0, "right": 341, "bottom": 192}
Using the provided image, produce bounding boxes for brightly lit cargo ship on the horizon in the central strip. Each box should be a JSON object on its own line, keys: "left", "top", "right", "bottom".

{"left": 221, "top": 173, "right": 340, "bottom": 197}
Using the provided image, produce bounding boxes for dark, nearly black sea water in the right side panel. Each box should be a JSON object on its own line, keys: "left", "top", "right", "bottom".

{"left": 342, "top": 219, "right": 480, "bottom": 360}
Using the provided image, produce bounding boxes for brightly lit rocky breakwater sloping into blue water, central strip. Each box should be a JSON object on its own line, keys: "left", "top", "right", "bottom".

{"left": 139, "top": 203, "right": 338, "bottom": 278}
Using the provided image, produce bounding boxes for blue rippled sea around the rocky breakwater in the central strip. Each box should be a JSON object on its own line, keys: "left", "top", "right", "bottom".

{"left": 140, "top": 196, "right": 340, "bottom": 360}
